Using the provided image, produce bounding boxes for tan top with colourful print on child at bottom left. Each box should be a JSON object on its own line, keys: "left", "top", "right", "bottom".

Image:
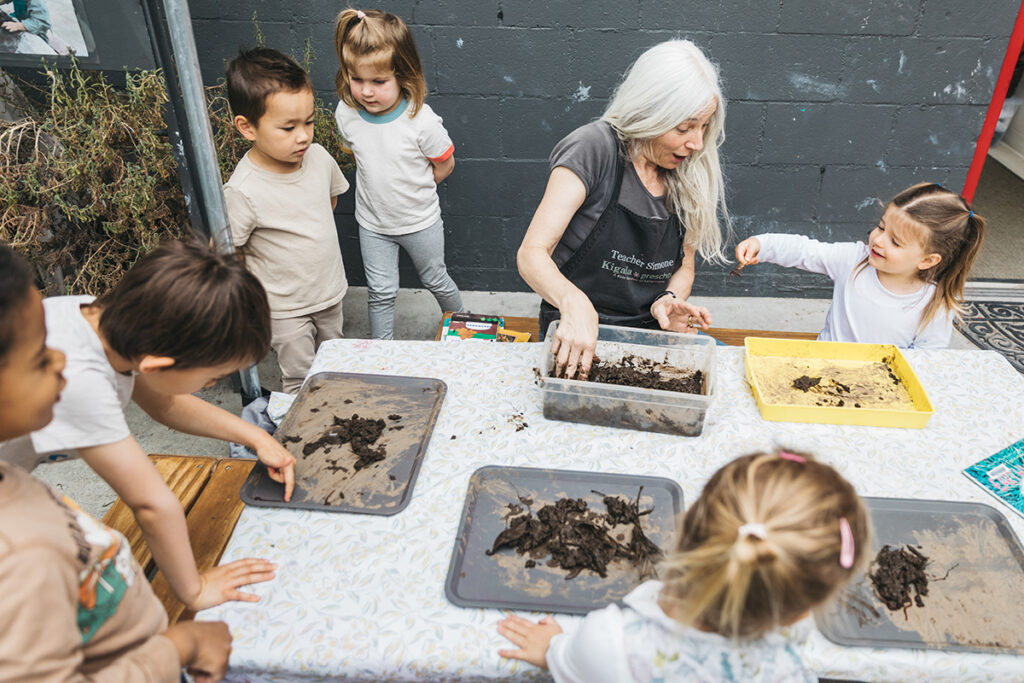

{"left": 0, "top": 463, "right": 181, "bottom": 683}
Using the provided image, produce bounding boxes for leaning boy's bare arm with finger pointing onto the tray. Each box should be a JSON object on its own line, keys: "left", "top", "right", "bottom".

{"left": 132, "top": 375, "right": 295, "bottom": 501}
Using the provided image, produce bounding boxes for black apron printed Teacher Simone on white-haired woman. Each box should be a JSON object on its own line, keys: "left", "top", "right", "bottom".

{"left": 539, "top": 153, "right": 685, "bottom": 339}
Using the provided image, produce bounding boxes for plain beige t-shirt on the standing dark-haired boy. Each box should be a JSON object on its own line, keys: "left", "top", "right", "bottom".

{"left": 224, "top": 142, "right": 348, "bottom": 318}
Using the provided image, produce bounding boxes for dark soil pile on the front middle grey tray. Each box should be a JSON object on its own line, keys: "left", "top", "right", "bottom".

{"left": 486, "top": 487, "right": 662, "bottom": 580}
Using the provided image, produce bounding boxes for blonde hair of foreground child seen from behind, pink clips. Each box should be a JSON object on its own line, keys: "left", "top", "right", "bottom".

{"left": 659, "top": 454, "right": 869, "bottom": 638}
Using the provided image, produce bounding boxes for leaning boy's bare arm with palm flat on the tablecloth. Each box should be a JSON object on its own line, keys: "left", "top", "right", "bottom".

{"left": 79, "top": 436, "right": 275, "bottom": 610}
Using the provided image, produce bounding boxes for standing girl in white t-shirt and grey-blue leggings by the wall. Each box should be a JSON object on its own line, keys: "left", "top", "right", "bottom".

{"left": 334, "top": 9, "right": 463, "bottom": 339}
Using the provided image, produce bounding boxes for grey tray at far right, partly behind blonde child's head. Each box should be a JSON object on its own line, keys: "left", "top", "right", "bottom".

{"left": 814, "top": 498, "right": 1024, "bottom": 654}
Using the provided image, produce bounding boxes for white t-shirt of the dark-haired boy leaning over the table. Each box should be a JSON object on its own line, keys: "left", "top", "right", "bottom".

{"left": 0, "top": 296, "right": 135, "bottom": 472}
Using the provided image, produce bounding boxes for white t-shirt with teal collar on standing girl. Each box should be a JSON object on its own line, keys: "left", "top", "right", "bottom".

{"left": 335, "top": 99, "right": 455, "bottom": 234}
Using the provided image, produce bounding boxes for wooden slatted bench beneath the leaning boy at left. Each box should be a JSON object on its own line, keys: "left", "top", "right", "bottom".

{"left": 103, "top": 455, "right": 256, "bottom": 624}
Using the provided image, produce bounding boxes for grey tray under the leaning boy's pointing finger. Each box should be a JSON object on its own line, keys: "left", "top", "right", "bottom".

{"left": 241, "top": 373, "right": 447, "bottom": 515}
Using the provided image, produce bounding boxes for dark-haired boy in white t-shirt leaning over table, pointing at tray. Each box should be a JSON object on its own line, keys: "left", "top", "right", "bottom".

{"left": 0, "top": 242, "right": 294, "bottom": 610}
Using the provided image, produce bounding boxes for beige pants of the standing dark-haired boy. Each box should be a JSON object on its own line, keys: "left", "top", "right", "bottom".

{"left": 270, "top": 301, "right": 344, "bottom": 393}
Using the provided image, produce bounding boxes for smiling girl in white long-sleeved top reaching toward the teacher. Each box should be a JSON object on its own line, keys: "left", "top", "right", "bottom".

{"left": 736, "top": 182, "right": 985, "bottom": 348}
